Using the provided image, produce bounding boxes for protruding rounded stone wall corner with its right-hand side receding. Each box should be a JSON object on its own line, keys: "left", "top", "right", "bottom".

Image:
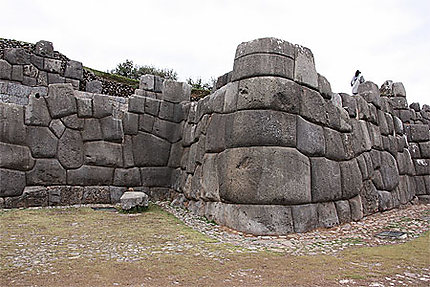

{"left": 167, "top": 38, "right": 430, "bottom": 234}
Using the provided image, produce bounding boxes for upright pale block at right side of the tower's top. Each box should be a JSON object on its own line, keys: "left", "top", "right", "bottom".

{"left": 294, "top": 45, "right": 318, "bottom": 88}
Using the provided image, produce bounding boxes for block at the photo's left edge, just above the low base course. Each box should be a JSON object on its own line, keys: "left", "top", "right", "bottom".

{"left": 0, "top": 168, "right": 25, "bottom": 197}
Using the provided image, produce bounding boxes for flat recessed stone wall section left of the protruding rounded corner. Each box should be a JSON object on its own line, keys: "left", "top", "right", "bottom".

{"left": 0, "top": 76, "right": 190, "bottom": 208}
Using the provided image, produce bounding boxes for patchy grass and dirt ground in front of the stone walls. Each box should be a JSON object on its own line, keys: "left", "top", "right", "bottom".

{"left": 0, "top": 205, "right": 430, "bottom": 287}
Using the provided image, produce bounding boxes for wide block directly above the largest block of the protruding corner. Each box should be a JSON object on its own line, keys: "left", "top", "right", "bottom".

{"left": 225, "top": 110, "right": 296, "bottom": 148}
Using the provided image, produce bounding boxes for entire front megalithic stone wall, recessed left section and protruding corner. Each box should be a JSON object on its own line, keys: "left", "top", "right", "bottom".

{"left": 0, "top": 38, "right": 430, "bottom": 234}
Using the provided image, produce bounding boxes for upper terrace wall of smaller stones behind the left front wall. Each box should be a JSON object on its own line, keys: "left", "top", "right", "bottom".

{"left": 0, "top": 39, "right": 134, "bottom": 99}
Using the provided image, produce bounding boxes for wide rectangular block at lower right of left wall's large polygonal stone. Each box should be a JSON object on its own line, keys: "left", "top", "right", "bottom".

{"left": 84, "top": 141, "right": 123, "bottom": 167}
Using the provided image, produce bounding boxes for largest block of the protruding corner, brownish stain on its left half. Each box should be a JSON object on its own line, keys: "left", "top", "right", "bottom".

{"left": 218, "top": 147, "right": 311, "bottom": 204}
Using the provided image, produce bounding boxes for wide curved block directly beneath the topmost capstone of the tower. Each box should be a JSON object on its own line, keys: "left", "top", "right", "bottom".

{"left": 231, "top": 54, "right": 296, "bottom": 82}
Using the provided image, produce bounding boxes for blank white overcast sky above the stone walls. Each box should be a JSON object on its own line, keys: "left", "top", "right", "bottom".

{"left": 0, "top": 0, "right": 430, "bottom": 104}
